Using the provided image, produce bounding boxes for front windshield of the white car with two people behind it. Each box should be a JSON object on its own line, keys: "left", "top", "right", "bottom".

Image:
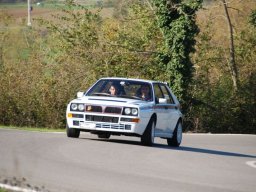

{"left": 86, "top": 79, "right": 153, "bottom": 101}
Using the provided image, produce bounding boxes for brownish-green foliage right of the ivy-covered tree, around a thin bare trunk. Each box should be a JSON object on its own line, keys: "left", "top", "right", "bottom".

{"left": 186, "top": 1, "right": 256, "bottom": 133}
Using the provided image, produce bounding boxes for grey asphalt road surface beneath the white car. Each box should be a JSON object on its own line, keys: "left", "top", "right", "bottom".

{"left": 0, "top": 129, "right": 256, "bottom": 192}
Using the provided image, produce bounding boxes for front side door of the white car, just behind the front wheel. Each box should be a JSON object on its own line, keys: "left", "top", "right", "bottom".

{"left": 153, "top": 83, "right": 169, "bottom": 134}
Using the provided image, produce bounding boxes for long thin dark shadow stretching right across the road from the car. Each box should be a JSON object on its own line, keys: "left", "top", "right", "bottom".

{"left": 155, "top": 144, "right": 256, "bottom": 158}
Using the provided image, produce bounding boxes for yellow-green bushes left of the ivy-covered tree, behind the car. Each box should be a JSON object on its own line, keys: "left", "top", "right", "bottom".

{"left": 0, "top": 1, "right": 162, "bottom": 128}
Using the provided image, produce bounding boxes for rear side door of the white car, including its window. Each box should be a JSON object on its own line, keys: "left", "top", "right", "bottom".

{"left": 160, "top": 84, "right": 180, "bottom": 132}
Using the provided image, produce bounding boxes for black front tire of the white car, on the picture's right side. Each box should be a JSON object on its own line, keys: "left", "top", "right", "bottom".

{"left": 141, "top": 119, "right": 156, "bottom": 146}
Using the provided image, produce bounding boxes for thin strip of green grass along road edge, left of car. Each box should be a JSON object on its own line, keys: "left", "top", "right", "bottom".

{"left": 0, "top": 125, "right": 65, "bottom": 132}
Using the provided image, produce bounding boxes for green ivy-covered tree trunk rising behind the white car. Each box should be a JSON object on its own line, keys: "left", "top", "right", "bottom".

{"left": 153, "top": 0, "right": 202, "bottom": 102}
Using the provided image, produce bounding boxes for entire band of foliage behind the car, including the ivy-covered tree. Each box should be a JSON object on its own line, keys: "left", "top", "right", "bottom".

{"left": 0, "top": 0, "right": 256, "bottom": 133}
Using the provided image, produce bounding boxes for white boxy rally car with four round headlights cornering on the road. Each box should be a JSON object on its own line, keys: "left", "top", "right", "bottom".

{"left": 66, "top": 78, "right": 182, "bottom": 146}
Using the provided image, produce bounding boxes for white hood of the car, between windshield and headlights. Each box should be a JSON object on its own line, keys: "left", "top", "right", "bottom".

{"left": 70, "top": 96, "right": 152, "bottom": 106}
